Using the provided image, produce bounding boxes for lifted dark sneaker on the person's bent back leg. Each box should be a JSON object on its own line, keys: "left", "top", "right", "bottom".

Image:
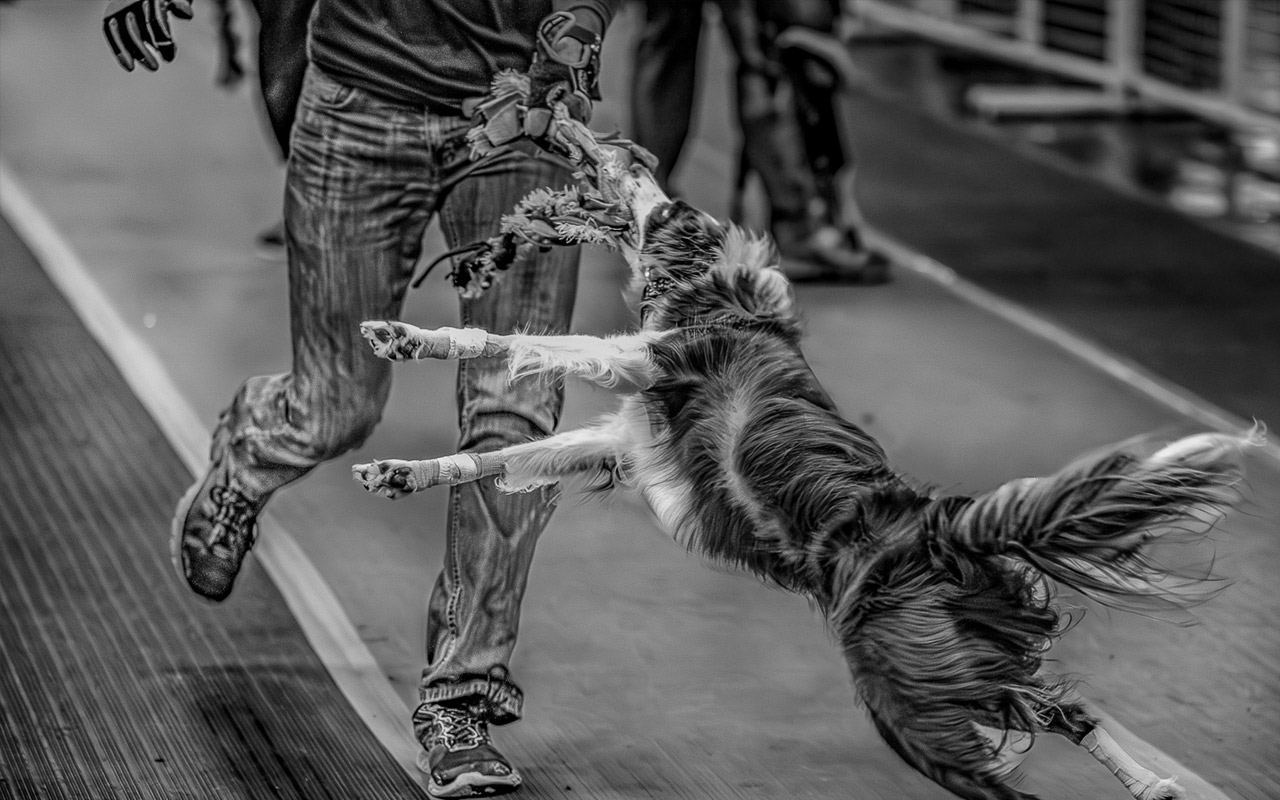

{"left": 170, "top": 430, "right": 265, "bottom": 602}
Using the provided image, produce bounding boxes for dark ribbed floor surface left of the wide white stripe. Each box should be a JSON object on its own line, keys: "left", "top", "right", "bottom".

{"left": 0, "top": 213, "right": 425, "bottom": 800}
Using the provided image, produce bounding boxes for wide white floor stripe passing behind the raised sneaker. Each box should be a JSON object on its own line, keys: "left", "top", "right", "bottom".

{"left": 0, "top": 157, "right": 426, "bottom": 788}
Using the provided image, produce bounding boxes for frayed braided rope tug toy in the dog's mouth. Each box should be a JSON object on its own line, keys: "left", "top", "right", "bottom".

{"left": 413, "top": 70, "right": 657, "bottom": 298}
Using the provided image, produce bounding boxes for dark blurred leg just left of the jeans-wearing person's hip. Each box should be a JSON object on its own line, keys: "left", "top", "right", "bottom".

{"left": 245, "top": 0, "right": 316, "bottom": 253}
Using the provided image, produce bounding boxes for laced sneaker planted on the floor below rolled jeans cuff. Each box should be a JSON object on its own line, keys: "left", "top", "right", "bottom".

{"left": 413, "top": 703, "right": 520, "bottom": 797}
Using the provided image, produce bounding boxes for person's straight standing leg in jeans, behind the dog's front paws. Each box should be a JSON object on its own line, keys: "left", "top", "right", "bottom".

{"left": 413, "top": 134, "right": 579, "bottom": 796}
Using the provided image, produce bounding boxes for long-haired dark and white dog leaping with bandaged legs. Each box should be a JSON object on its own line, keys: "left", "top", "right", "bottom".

{"left": 353, "top": 87, "right": 1261, "bottom": 800}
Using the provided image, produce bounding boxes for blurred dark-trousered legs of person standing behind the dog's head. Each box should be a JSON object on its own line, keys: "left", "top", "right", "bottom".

{"left": 631, "top": 0, "right": 888, "bottom": 283}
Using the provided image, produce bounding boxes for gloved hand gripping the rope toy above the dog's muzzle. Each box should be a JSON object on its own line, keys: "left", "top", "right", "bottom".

{"left": 525, "top": 12, "right": 600, "bottom": 138}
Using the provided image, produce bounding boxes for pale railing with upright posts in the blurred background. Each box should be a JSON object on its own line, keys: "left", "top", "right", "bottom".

{"left": 846, "top": 0, "right": 1280, "bottom": 132}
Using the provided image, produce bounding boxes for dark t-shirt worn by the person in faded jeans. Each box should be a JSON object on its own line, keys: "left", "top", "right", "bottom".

{"left": 310, "top": 0, "right": 621, "bottom": 111}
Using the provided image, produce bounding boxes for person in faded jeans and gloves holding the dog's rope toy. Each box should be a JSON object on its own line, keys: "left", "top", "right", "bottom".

{"left": 104, "top": 0, "right": 618, "bottom": 797}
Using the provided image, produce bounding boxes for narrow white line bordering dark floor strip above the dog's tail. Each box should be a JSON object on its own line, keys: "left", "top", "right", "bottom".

{"left": 867, "top": 230, "right": 1280, "bottom": 462}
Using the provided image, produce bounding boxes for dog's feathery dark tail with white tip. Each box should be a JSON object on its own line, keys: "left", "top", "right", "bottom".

{"left": 938, "top": 426, "right": 1263, "bottom": 608}
